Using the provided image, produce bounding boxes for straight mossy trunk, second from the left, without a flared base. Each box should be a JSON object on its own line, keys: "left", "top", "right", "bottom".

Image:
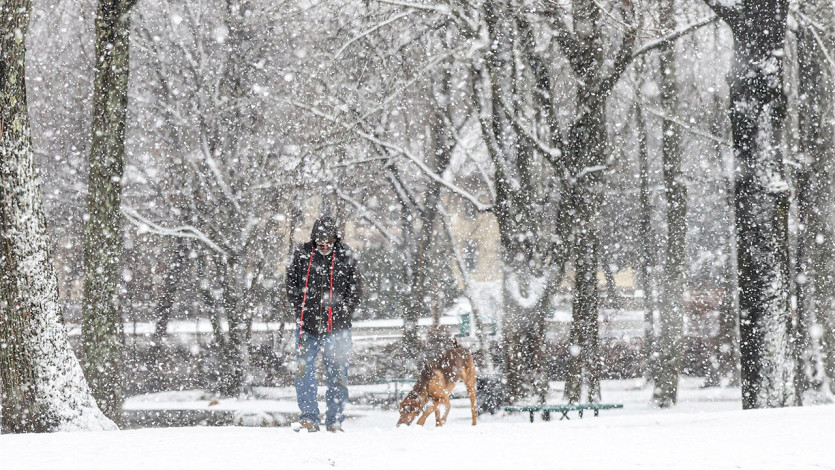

{"left": 81, "top": 0, "right": 133, "bottom": 423}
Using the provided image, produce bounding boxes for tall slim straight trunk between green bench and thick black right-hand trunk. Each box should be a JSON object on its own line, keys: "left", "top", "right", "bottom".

{"left": 653, "top": 0, "right": 687, "bottom": 408}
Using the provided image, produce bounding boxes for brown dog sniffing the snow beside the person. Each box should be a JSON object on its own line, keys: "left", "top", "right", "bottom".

{"left": 397, "top": 338, "right": 478, "bottom": 426}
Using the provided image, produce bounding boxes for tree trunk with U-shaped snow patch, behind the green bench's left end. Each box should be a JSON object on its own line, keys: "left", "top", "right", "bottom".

{"left": 476, "top": 2, "right": 548, "bottom": 401}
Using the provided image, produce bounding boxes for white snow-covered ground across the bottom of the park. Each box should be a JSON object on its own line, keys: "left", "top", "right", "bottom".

{"left": 0, "top": 379, "right": 835, "bottom": 470}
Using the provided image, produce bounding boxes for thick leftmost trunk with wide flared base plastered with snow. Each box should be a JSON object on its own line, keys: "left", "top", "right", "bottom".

{"left": 0, "top": 0, "right": 116, "bottom": 432}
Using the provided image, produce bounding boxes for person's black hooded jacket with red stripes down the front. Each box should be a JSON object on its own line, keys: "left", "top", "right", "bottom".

{"left": 286, "top": 217, "right": 362, "bottom": 336}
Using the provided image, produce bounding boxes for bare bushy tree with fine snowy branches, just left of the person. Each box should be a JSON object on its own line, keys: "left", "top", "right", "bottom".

{"left": 129, "top": 0, "right": 299, "bottom": 395}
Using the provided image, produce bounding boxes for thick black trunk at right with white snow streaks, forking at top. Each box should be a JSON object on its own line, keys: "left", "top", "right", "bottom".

{"left": 708, "top": 0, "right": 797, "bottom": 409}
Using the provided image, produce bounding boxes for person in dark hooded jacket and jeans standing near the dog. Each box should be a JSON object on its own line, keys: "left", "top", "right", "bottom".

{"left": 286, "top": 217, "right": 362, "bottom": 432}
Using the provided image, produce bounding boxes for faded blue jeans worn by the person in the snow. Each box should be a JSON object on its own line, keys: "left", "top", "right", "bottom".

{"left": 295, "top": 330, "right": 351, "bottom": 426}
